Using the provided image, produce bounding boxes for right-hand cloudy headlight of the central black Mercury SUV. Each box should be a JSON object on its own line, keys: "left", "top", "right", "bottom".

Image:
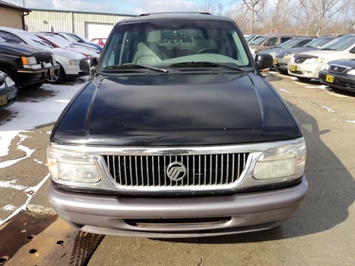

{"left": 253, "top": 139, "right": 306, "bottom": 180}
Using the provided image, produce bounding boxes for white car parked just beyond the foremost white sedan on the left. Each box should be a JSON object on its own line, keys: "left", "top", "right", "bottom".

{"left": 34, "top": 32, "right": 100, "bottom": 58}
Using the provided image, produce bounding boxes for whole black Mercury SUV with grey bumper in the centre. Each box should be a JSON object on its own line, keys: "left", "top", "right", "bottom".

{"left": 47, "top": 13, "right": 308, "bottom": 238}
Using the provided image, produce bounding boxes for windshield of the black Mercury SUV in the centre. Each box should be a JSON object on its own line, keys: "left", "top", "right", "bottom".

{"left": 98, "top": 20, "right": 252, "bottom": 71}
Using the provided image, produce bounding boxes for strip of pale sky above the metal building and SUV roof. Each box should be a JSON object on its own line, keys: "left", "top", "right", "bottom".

{"left": 3, "top": 0, "right": 218, "bottom": 15}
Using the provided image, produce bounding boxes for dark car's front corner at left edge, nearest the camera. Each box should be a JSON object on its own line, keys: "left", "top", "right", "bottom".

{"left": 0, "top": 71, "right": 17, "bottom": 109}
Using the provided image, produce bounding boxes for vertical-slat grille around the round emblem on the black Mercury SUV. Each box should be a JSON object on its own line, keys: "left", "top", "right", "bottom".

{"left": 103, "top": 153, "right": 249, "bottom": 187}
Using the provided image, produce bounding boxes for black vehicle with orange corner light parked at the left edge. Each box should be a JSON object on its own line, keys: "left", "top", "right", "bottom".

{"left": 0, "top": 37, "right": 59, "bottom": 89}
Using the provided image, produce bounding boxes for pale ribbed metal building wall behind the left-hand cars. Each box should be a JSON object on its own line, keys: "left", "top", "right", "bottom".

{"left": 25, "top": 9, "right": 134, "bottom": 39}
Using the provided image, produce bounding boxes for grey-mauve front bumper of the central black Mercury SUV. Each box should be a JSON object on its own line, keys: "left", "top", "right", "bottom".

{"left": 49, "top": 176, "right": 308, "bottom": 238}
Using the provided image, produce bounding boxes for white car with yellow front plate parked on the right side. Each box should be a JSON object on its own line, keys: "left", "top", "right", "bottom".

{"left": 287, "top": 34, "right": 355, "bottom": 81}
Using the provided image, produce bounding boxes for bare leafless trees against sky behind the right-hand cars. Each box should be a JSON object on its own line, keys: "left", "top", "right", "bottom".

{"left": 199, "top": 0, "right": 355, "bottom": 36}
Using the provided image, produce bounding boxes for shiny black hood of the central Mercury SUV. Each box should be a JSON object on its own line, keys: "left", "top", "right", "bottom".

{"left": 51, "top": 73, "right": 301, "bottom": 146}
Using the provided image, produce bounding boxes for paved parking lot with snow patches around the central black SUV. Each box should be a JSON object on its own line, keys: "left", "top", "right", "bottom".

{"left": 0, "top": 73, "right": 355, "bottom": 265}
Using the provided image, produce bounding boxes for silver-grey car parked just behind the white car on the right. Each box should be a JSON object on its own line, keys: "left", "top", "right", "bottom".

{"left": 274, "top": 36, "right": 337, "bottom": 74}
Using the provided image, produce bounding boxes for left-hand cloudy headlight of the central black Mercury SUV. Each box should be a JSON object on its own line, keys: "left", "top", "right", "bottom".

{"left": 47, "top": 145, "right": 100, "bottom": 183}
